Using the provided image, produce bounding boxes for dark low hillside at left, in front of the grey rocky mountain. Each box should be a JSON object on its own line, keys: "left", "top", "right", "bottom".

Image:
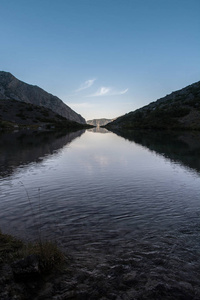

{"left": 0, "top": 99, "right": 89, "bottom": 129}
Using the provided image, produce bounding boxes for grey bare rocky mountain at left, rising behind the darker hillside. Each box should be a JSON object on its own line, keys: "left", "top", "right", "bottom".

{"left": 0, "top": 71, "right": 86, "bottom": 124}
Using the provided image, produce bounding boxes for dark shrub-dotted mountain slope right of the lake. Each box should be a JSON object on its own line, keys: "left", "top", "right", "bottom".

{"left": 105, "top": 81, "right": 200, "bottom": 130}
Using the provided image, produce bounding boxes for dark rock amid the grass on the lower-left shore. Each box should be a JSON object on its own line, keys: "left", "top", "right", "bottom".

{"left": 12, "top": 254, "right": 40, "bottom": 280}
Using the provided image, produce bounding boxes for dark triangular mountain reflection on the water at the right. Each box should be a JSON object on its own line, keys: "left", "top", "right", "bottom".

{"left": 111, "top": 130, "right": 200, "bottom": 172}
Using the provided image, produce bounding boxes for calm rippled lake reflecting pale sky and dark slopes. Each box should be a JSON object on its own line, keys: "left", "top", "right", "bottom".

{"left": 0, "top": 129, "right": 200, "bottom": 296}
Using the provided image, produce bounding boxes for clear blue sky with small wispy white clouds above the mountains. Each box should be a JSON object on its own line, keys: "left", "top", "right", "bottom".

{"left": 0, "top": 0, "right": 200, "bottom": 119}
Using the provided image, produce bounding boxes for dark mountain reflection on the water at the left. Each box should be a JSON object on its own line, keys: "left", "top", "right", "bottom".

{"left": 0, "top": 130, "right": 85, "bottom": 178}
